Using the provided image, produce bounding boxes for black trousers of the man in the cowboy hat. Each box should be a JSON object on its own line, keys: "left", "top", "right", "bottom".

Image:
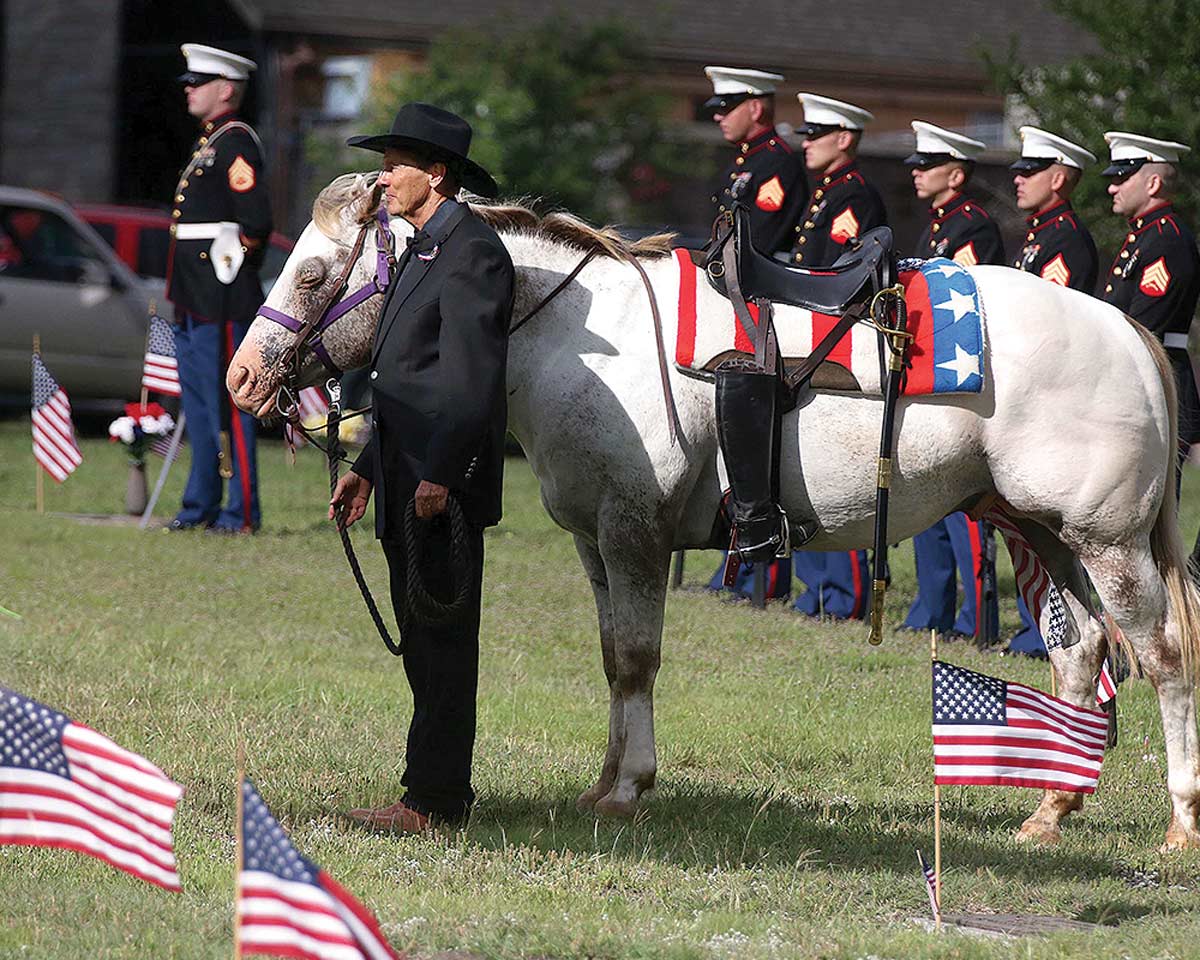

{"left": 380, "top": 520, "right": 484, "bottom": 821}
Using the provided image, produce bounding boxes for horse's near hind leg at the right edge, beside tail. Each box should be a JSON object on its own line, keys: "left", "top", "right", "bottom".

{"left": 1084, "top": 539, "right": 1200, "bottom": 850}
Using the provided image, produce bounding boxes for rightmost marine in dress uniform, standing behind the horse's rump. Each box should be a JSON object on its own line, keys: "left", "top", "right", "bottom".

{"left": 1103, "top": 131, "right": 1200, "bottom": 460}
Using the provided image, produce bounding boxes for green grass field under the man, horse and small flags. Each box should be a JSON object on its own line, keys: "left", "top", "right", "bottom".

{"left": 0, "top": 419, "right": 1200, "bottom": 960}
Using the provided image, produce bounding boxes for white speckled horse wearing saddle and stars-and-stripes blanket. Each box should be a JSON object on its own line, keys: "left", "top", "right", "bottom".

{"left": 227, "top": 176, "right": 1200, "bottom": 847}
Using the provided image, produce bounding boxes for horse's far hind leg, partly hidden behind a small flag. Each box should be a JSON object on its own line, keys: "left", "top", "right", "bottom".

{"left": 1014, "top": 518, "right": 1108, "bottom": 844}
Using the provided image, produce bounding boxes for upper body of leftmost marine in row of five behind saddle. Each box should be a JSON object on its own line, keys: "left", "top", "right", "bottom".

{"left": 702, "top": 66, "right": 809, "bottom": 256}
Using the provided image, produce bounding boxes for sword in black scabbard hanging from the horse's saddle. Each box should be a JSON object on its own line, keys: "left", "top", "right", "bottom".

{"left": 868, "top": 283, "right": 912, "bottom": 647}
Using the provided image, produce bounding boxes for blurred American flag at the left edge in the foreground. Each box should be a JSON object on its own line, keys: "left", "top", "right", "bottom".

{"left": 0, "top": 688, "right": 184, "bottom": 893}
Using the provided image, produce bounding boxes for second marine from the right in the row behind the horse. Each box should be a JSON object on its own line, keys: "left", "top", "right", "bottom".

{"left": 1008, "top": 126, "right": 1099, "bottom": 658}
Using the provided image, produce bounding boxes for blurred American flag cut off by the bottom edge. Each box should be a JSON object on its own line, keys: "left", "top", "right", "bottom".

{"left": 238, "top": 780, "right": 397, "bottom": 960}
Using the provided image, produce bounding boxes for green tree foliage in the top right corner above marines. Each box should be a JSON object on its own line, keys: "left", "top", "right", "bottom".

{"left": 990, "top": 0, "right": 1200, "bottom": 247}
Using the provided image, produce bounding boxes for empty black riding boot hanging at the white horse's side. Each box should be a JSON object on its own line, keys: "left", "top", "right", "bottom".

{"left": 716, "top": 368, "right": 815, "bottom": 563}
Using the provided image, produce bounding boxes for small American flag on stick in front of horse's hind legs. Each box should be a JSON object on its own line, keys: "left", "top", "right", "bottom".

{"left": 934, "top": 660, "right": 1109, "bottom": 793}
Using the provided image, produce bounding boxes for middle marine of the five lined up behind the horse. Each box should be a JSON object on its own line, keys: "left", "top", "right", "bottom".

{"left": 904, "top": 120, "right": 1004, "bottom": 636}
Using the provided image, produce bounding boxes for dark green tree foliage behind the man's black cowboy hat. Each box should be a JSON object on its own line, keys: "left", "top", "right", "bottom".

{"left": 333, "top": 14, "right": 683, "bottom": 221}
